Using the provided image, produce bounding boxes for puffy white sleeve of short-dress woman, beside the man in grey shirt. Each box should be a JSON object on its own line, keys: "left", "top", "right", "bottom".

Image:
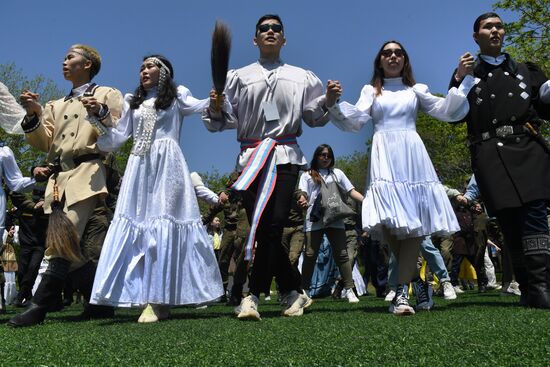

{"left": 328, "top": 85, "right": 374, "bottom": 132}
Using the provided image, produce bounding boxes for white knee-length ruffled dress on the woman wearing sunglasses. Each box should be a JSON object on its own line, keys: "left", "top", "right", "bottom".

{"left": 330, "top": 78, "right": 476, "bottom": 239}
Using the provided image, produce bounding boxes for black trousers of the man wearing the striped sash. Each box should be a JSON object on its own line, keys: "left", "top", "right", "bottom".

{"left": 243, "top": 164, "right": 301, "bottom": 296}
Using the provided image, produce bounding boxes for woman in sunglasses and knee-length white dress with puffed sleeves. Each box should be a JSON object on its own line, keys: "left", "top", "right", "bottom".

{"left": 327, "top": 41, "right": 474, "bottom": 315}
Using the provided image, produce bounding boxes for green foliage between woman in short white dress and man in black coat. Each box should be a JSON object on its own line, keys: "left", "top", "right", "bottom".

{"left": 416, "top": 113, "right": 472, "bottom": 189}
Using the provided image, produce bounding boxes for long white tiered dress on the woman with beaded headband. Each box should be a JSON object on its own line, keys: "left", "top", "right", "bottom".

{"left": 91, "top": 86, "right": 223, "bottom": 307}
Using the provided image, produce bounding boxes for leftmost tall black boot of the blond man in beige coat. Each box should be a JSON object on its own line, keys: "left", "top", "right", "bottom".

{"left": 8, "top": 258, "right": 71, "bottom": 327}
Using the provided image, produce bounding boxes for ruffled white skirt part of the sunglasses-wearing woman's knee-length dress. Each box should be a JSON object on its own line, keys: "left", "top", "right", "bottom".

{"left": 362, "top": 129, "right": 460, "bottom": 239}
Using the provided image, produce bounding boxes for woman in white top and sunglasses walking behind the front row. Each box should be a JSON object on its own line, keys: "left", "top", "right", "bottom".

{"left": 298, "top": 144, "right": 363, "bottom": 303}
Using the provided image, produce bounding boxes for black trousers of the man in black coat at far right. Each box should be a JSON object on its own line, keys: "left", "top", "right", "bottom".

{"left": 496, "top": 200, "right": 548, "bottom": 292}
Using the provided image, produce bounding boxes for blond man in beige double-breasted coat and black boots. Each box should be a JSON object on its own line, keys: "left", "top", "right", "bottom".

{"left": 8, "top": 45, "right": 122, "bottom": 327}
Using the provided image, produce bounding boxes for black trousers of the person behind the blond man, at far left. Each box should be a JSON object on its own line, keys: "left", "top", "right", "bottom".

{"left": 17, "top": 245, "right": 44, "bottom": 299}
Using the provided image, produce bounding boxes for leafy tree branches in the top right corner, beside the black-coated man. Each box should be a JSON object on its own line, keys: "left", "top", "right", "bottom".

{"left": 493, "top": 0, "right": 550, "bottom": 75}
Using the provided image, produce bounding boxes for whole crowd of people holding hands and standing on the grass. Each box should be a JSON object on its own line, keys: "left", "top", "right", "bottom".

{"left": 0, "top": 13, "right": 550, "bottom": 327}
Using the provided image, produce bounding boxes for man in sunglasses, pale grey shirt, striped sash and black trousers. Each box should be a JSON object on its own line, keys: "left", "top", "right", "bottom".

{"left": 203, "top": 14, "right": 334, "bottom": 320}
